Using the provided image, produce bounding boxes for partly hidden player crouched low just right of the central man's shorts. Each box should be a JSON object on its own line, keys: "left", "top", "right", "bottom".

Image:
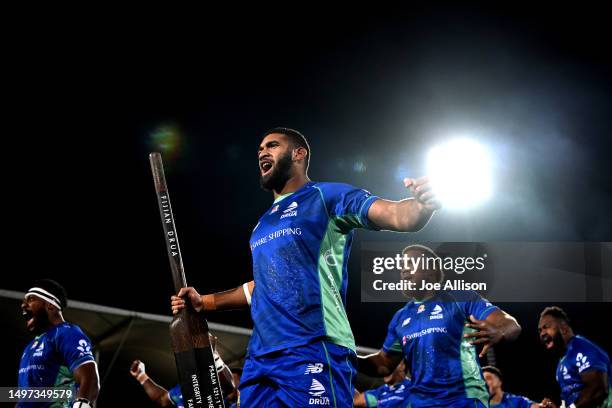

{"left": 353, "top": 360, "right": 410, "bottom": 408}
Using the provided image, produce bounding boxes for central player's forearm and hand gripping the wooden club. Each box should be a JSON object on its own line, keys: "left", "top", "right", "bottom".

{"left": 170, "top": 281, "right": 255, "bottom": 314}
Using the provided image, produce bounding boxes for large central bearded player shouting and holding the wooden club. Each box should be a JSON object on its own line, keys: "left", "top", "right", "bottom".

{"left": 172, "top": 128, "right": 439, "bottom": 408}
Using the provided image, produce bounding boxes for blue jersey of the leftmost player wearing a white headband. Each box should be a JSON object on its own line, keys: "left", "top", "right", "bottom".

{"left": 18, "top": 322, "right": 95, "bottom": 408}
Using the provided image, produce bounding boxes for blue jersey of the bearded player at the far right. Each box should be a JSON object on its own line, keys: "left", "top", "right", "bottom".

{"left": 557, "top": 336, "right": 612, "bottom": 407}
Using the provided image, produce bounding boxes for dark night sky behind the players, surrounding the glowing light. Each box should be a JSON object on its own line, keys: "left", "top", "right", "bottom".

{"left": 1, "top": 5, "right": 612, "bottom": 404}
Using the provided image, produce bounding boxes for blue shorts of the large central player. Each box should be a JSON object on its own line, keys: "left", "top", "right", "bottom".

{"left": 239, "top": 341, "right": 357, "bottom": 408}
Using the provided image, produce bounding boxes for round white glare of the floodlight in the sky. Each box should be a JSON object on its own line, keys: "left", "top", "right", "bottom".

{"left": 427, "top": 138, "right": 492, "bottom": 209}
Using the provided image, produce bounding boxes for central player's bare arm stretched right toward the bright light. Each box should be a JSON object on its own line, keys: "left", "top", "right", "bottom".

{"left": 368, "top": 177, "right": 440, "bottom": 232}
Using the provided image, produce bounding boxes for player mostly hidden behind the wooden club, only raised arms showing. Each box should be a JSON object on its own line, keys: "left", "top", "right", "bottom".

{"left": 130, "top": 333, "right": 242, "bottom": 408}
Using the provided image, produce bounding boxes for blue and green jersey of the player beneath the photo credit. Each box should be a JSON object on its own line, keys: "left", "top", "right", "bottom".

{"left": 383, "top": 291, "right": 499, "bottom": 407}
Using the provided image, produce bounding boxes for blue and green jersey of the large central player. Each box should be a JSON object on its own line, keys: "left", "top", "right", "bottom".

{"left": 249, "top": 182, "right": 377, "bottom": 356}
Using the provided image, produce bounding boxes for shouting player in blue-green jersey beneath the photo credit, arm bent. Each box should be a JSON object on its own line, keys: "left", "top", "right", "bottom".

{"left": 359, "top": 245, "right": 521, "bottom": 408}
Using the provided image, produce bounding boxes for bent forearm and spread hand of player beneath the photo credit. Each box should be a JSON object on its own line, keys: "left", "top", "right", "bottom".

{"left": 465, "top": 310, "right": 521, "bottom": 357}
